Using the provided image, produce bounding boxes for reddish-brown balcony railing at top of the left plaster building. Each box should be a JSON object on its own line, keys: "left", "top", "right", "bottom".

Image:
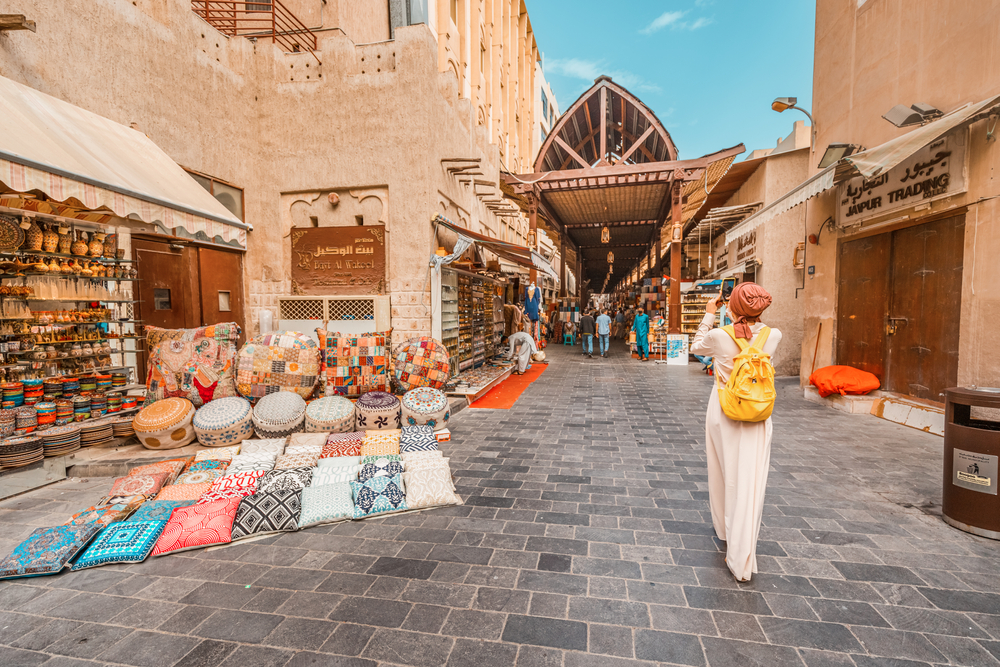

{"left": 191, "top": 0, "right": 320, "bottom": 63}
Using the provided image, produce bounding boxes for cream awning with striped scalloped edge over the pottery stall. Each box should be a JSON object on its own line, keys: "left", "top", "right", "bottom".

{"left": 0, "top": 77, "right": 252, "bottom": 247}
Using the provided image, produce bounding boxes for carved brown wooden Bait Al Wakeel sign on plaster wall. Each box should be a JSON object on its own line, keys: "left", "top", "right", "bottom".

{"left": 291, "top": 225, "right": 385, "bottom": 296}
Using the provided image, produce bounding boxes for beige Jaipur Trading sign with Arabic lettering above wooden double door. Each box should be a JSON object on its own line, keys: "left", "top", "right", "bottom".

{"left": 837, "top": 131, "right": 967, "bottom": 226}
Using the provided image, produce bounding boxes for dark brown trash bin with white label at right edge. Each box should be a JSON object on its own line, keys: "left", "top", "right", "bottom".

{"left": 941, "top": 387, "right": 1000, "bottom": 540}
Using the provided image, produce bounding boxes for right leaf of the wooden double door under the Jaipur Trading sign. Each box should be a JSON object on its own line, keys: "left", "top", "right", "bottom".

{"left": 882, "top": 215, "right": 965, "bottom": 403}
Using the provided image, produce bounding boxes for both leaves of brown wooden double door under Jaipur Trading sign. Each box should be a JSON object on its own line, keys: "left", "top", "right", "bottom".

{"left": 837, "top": 215, "right": 965, "bottom": 402}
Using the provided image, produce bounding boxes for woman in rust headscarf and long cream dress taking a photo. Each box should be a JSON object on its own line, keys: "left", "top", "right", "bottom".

{"left": 691, "top": 283, "right": 781, "bottom": 581}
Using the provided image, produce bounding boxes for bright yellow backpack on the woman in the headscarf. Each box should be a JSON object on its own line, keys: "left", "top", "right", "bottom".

{"left": 715, "top": 326, "right": 775, "bottom": 422}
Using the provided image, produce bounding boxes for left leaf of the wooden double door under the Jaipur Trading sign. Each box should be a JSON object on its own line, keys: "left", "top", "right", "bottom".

{"left": 837, "top": 234, "right": 890, "bottom": 380}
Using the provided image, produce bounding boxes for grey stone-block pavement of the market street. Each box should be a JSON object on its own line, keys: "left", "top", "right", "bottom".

{"left": 0, "top": 344, "right": 1000, "bottom": 667}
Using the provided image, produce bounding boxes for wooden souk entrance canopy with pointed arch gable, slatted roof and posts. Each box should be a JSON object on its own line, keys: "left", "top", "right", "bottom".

{"left": 502, "top": 76, "right": 745, "bottom": 333}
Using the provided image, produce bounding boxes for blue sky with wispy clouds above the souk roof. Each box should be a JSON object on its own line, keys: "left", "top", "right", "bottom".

{"left": 526, "top": 0, "right": 815, "bottom": 159}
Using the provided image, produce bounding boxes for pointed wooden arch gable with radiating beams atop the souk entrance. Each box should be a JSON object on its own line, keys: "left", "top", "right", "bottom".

{"left": 534, "top": 76, "right": 677, "bottom": 172}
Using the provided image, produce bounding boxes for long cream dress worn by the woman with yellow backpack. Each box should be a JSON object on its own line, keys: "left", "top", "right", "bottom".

{"left": 690, "top": 314, "right": 781, "bottom": 581}
